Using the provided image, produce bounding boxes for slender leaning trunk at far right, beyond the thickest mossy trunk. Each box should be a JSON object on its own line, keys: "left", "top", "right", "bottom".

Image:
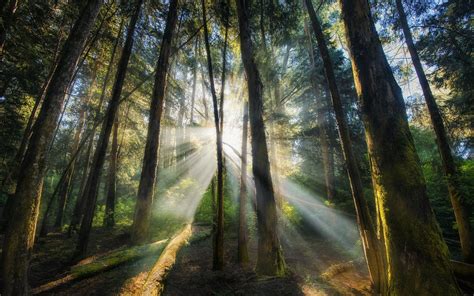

{"left": 396, "top": 0, "right": 474, "bottom": 263}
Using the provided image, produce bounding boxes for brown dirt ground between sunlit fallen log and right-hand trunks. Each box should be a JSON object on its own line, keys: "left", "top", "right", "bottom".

{"left": 164, "top": 225, "right": 371, "bottom": 296}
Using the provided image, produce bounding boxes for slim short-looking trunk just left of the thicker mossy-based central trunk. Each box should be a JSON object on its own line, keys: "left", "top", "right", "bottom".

{"left": 237, "top": 101, "right": 249, "bottom": 265}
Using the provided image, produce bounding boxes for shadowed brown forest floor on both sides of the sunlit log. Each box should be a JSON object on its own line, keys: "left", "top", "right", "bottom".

{"left": 24, "top": 226, "right": 370, "bottom": 296}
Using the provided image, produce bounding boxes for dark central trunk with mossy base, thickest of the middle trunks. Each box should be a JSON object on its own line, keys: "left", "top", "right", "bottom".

{"left": 236, "top": 0, "right": 285, "bottom": 275}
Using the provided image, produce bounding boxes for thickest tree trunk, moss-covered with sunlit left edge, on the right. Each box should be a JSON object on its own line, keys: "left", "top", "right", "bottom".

{"left": 339, "top": 0, "right": 459, "bottom": 295}
